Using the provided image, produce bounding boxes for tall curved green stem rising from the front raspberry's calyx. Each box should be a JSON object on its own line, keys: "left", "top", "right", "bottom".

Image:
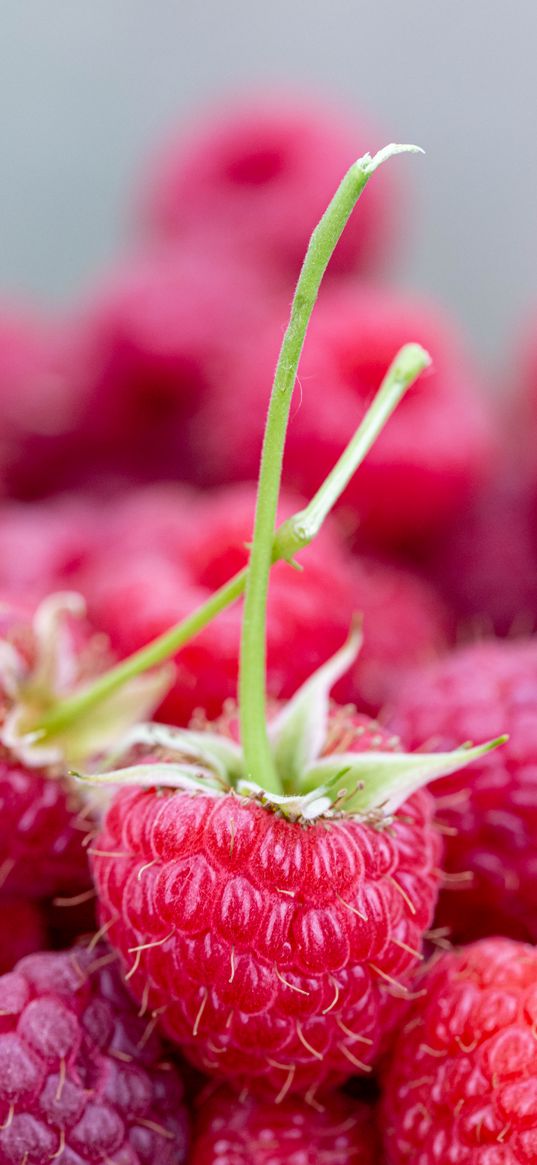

{"left": 239, "top": 146, "right": 416, "bottom": 793}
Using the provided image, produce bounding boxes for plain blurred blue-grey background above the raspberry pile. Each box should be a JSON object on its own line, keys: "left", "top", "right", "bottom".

{"left": 0, "top": 0, "right": 537, "bottom": 369}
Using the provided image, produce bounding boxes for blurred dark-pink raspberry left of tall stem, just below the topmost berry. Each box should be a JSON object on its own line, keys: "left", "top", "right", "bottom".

{"left": 71, "top": 246, "right": 272, "bottom": 481}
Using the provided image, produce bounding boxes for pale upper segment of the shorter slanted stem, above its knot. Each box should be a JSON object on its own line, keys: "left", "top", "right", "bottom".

{"left": 274, "top": 344, "right": 431, "bottom": 562}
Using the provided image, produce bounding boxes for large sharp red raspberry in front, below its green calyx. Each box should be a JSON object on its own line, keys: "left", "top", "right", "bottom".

{"left": 92, "top": 711, "right": 439, "bottom": 1099}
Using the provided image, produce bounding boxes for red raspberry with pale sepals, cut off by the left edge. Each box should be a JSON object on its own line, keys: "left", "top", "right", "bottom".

{"left": 0, "top": 596, "right": 106, "bottom": 898}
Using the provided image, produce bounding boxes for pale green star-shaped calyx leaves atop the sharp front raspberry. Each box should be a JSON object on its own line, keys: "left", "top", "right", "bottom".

{"left": 74, "top": 623, "right": 507, "bottom": 824}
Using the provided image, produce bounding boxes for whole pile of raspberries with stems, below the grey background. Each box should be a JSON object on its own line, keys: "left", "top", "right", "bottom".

{"left": 0, "top": 86, "right": 537, "bottom": 1165}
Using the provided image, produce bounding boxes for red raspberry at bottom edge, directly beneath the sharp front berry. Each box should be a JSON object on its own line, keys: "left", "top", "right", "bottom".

{"left": 190, "top": 1089, "right": 379, "bottom": 1165}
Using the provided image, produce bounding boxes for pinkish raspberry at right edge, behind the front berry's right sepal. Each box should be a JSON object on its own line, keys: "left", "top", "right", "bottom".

{"left": 389, "top": 640, "right": 537, "bottom": 940}
